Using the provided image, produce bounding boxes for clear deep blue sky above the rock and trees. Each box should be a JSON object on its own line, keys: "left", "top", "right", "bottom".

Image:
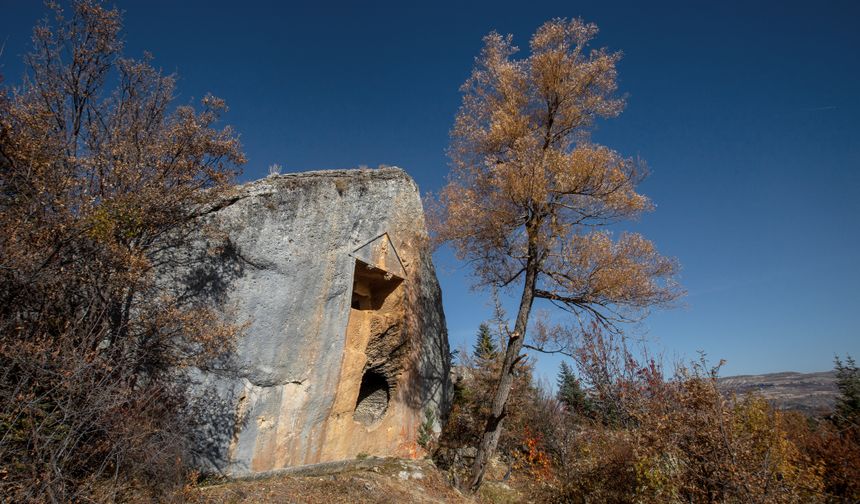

{"left": 0, "top": 0, "right": 860, "bottom": 376}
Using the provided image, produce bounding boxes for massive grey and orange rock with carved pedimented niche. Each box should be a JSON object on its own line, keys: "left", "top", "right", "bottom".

{"left": 174, "top": 168, "right": 450, "bottom": 475}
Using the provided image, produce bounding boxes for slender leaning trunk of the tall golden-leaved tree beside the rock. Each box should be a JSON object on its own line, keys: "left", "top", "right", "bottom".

{"left": 468, "top": 233, "right": 538, "bottom": 493}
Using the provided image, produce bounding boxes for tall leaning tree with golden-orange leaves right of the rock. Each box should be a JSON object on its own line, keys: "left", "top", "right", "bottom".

{"left": 429, "top": 19, "right": 681, "bottom": 491}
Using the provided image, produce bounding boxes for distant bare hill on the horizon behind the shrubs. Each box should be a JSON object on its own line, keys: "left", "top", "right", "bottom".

{"left": 718, "top": 371, "right": 838, "bottom": 414}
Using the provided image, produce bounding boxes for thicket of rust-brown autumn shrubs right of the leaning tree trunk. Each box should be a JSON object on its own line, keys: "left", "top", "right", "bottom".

{"left": 512, "top": 328, "right": 844, "bottom": 503}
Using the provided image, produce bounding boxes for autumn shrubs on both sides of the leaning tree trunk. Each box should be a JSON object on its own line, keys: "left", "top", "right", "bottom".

{"left": 435, "top": 324, "right": 860, "bottom": 503}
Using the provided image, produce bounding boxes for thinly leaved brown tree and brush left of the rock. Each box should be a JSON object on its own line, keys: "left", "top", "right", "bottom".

{"left": 0, "top": 0, "right": 243, "bottom": 502}
